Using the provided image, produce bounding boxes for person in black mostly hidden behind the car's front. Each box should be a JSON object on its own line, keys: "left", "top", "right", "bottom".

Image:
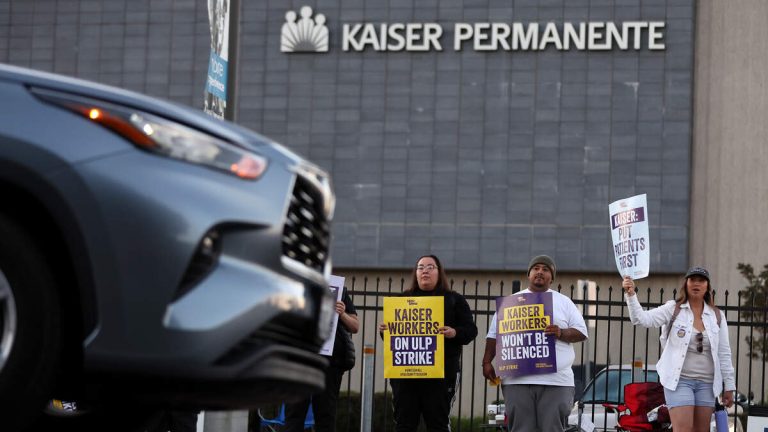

{"left": 283, "top": 288, "right": 360, "bottom": 432}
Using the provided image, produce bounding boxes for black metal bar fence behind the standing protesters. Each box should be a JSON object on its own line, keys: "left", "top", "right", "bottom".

{"left": 336, "top": 278, "right": 768, "bottom": 431}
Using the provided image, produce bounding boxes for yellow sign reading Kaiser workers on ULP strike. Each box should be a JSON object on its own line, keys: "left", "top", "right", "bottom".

{"left": 384, "top": 296, "right": 445, "bottom": 378}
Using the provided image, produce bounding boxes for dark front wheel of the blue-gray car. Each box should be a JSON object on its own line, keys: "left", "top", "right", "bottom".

{"left": 0, "top": 214, "right": 62, "bottom": 431}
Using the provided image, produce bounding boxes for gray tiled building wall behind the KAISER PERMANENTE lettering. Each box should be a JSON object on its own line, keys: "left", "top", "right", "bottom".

{"left": 0, "top": 0, "right": 696, "bottom": 273}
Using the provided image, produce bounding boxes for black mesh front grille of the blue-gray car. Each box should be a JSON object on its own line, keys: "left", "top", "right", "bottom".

{"left": 283, "top": 175, "right": 330, "bottom": 273}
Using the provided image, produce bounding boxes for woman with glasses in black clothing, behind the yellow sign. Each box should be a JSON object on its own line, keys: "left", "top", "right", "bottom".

{"left": 379, "top": 255, "right": 477, "bottom": 432}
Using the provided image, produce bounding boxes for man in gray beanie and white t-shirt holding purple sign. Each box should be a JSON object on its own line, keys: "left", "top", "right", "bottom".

{"left": 483, "top": 255, "right": 587, "bottom": 432}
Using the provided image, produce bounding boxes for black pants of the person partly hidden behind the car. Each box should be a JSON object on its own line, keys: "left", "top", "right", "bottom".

{"left": 283, "top": 366, "right": 344, "bottom": 432}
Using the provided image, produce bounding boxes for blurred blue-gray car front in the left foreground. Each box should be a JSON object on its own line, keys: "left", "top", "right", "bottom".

{"left": 0, "top": 65, "right": 334, "bottom": 431}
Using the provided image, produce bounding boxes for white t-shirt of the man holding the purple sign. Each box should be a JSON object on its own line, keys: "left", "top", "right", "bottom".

{"left": 486, "top": 289, "right": 589, "bottom": 387}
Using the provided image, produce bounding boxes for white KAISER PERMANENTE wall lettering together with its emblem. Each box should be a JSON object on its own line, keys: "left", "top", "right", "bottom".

{"left": 280, "top": 6, "right": 666, "bottom": 52}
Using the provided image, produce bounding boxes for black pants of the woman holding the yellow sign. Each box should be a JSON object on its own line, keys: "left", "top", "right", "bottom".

{"left": 389, "top": 358, "right": 459, "bottom": 432}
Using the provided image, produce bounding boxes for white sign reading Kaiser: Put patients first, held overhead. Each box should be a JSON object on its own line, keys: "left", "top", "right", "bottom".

{"left": 608, "top": 194, "right": 651, "bottom": 279}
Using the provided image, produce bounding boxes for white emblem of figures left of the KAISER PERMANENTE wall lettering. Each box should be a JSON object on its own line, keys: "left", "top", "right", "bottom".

{"left": 280, "top": 6, "right": 328, "bottom": 52}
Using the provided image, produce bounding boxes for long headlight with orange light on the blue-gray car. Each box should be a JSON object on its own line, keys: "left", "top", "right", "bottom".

{"left": 34, "top": 90, "right": 268, "bottom": 180}
